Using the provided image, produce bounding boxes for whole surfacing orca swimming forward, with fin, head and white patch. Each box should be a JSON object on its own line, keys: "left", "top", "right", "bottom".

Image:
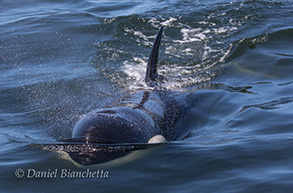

{"left": 36, "top": 27, "right": 196, "bottom": 166}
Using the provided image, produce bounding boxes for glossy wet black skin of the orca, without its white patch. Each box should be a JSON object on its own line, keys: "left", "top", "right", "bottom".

{"left": 69, "top": 27, "right": 194, "bottom": 165}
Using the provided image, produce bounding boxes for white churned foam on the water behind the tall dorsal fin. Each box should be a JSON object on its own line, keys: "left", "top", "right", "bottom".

{"left": 117, "top": 17, "right": 238, "bottom": 90}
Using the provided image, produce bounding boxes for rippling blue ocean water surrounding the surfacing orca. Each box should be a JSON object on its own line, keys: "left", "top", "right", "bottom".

{"left": 0, "top": 0, "right": 293, "bottom": 193}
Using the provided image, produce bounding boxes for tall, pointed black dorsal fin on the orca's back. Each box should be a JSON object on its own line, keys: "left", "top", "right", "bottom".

{"left": 145, "top": 27, "right": 164, "bottom": 86}
